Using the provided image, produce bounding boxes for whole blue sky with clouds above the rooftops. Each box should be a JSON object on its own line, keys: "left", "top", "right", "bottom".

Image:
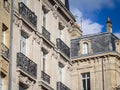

{"left": 69, "top": 0, "right": 120, "bottom": 38}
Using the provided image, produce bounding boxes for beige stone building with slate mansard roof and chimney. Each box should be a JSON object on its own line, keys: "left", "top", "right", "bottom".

{"left": 71, "top": 18, "right": 120, "bottom": 90}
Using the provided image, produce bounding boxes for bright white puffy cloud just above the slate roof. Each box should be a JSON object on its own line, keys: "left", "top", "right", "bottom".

{"left": 72, "top": 8, "right": 103, "bottom": 35}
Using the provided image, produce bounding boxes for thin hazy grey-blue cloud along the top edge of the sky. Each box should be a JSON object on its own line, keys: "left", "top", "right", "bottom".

{"left": 70, "top": 0, "right": 115, "bottom": 12}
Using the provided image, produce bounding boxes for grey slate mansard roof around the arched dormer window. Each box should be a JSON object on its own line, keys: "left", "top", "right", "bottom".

{"left": 71, "top": 33, "right": 119, "bottom": 58}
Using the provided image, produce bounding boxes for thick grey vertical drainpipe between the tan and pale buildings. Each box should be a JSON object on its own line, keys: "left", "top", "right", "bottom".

{"left": 8, "top": 0, "right": 14, "bottom": 90}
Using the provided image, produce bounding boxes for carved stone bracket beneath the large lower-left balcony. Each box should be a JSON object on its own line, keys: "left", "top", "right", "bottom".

{"left": 18, "top": 72, "right": 34, "bottom": 89}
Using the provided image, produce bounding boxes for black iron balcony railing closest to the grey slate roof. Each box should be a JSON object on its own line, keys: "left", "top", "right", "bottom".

{"left": 56, "top": 38, "right": 70, "bottom": 58}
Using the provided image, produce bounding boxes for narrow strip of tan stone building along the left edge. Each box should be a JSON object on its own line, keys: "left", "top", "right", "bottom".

{"left": 0, "top": 0, "right": 10, "bottom": 90}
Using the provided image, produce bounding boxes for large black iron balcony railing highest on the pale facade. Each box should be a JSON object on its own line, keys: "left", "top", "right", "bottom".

{"left": 19, "top": 2, "right": 37, "bottom": 27}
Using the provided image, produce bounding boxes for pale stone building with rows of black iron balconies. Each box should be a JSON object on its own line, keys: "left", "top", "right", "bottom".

{"left": 9, "top": 0, "right": 75, "bottom": 90}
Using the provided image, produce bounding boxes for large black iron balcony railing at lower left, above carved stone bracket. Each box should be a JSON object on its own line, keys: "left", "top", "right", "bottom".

{"left": 17, "top": 52, "right": 37, "bottom": 78}
